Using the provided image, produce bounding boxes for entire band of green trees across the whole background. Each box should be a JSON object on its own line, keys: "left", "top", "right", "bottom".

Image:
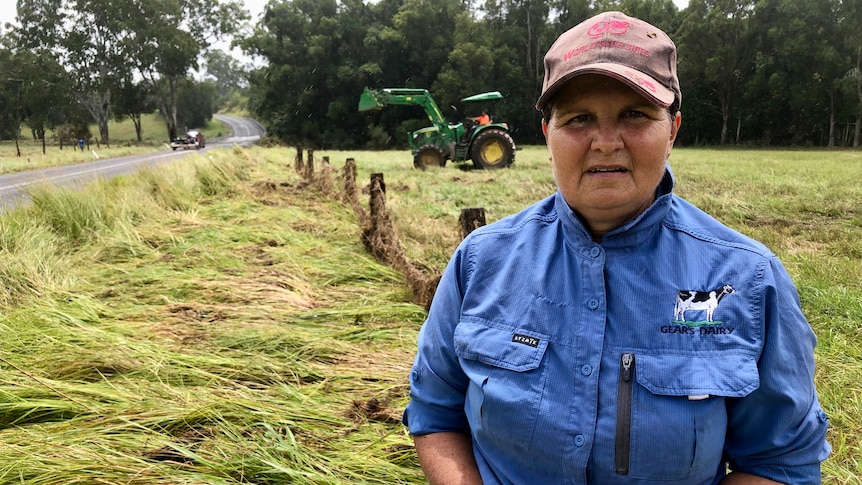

{"left": 0, "top": 0, "right": 862, "bottom": 149}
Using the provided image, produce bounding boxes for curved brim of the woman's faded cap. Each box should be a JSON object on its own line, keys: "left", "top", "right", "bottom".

{"left": 536, "top": 63, "right": 676, "bottom": 111}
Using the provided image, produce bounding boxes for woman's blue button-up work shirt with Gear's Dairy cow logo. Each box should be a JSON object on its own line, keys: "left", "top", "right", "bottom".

{"left": 404, "top": 173, "right": 830, "bottom": 485}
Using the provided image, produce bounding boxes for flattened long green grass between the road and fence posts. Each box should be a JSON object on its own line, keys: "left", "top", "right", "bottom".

{"left": 0, "top": 149, "right": 423, "bottom": 484}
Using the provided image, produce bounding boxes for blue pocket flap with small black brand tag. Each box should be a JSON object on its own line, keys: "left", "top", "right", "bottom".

{"left": 454, "top": 321, "right": 548, "bottom": 372}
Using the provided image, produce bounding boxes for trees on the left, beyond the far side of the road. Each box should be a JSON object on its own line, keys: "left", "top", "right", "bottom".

{"left": 0, "top": 0, "right": 248, "bottom": 149}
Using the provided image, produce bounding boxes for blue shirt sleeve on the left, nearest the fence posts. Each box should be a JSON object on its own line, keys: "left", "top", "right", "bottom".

{"left": 402, "top": 244, "right": 469, "bottom": 435}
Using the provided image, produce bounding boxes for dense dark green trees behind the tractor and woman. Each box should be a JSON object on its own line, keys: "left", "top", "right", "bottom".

{"left": 243, "top": 0, "right": 862, "bottom": 148}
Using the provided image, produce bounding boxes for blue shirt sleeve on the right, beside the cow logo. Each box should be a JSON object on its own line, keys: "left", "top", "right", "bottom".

{"left": 725, "top": 257, "right": 831, "bottom": 485}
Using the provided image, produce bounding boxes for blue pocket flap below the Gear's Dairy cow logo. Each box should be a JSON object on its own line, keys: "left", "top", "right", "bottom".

{"left": 635, "top": 354, "right": 760, "bottom": 397}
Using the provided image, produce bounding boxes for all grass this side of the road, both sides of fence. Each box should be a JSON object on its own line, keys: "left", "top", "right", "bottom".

{"left": 0, "top": 143, "right": 862, "bottom": 484}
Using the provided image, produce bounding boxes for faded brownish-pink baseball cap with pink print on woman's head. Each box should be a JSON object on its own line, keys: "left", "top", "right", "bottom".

{"left": 536, "top": 12, "right": 682, "bottom": 111}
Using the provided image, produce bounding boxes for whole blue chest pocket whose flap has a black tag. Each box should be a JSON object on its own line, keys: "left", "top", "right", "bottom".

{"left": 454, "top": 321, "right": 548, "bottom": 449}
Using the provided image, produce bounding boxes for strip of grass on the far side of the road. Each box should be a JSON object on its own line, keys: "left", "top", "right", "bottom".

{"left": 0, "top": 113, "right": 230, "bottom": 175}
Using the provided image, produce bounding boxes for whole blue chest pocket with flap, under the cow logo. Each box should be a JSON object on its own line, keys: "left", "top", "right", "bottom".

{"left": 629, "top": 354, "right": 760, "bottom": 483}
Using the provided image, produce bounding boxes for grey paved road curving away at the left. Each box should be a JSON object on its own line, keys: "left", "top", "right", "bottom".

{"left": 0, "top": 115, "right": 265, "bottom": 210}
